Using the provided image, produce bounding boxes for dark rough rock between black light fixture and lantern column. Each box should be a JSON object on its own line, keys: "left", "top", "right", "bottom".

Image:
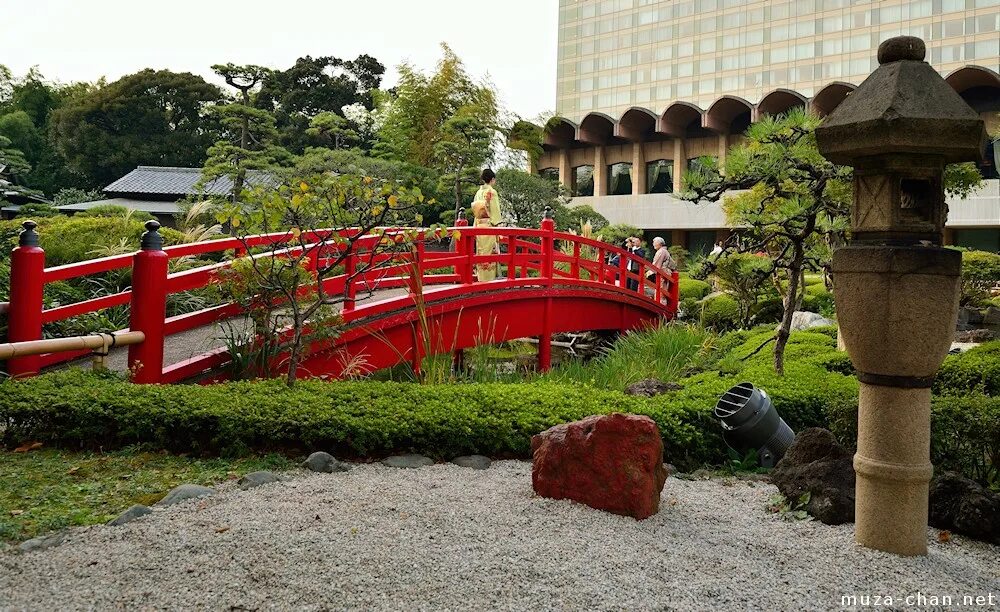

{"left": 771, "top": 427, "right": 854, "bottom": 525}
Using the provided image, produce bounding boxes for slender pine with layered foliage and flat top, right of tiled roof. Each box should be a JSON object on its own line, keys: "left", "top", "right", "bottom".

{"left": 202, "top": 64, "right": 290, "bottom": 203}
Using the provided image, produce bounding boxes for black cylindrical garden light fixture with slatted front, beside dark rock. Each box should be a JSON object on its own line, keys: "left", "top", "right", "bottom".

{"left": 712, "top": 382, "right": 795, "bottom": 468}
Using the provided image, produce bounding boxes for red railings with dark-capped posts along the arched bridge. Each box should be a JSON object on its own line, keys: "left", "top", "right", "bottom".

{"left": 7, "top": 213, "right": 678, "bottom": 382}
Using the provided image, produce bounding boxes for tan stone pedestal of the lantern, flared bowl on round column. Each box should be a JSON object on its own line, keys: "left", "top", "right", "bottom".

{"left": 833, "top": 246, "right": 962, "bottom": 555}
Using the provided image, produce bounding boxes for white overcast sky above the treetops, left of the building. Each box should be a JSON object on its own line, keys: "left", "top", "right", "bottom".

{"left": 0, "top": 0, "right": 558, "bottom": 119}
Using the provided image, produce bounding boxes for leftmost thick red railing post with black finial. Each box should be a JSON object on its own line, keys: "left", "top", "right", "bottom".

{"left": 7, "top": 221, "right": 45, "bottom": 377}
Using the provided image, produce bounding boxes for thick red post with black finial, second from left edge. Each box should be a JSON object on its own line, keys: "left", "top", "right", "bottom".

{"left": 128, "top": 221, "right": 169, "bottom": 384}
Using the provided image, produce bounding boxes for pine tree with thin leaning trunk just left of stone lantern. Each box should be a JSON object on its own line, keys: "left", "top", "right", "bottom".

{"left": 684, "top": 109, "right": 980, "bottom": 374}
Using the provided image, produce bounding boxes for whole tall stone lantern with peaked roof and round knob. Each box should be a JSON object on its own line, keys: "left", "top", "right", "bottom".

{"left": 816, "top": 36, "right": 986, "bottom": 555}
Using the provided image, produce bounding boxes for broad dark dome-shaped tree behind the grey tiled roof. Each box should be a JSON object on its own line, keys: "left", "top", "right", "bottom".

{"left": 51, "top": 69, "right": 222, "bottom": 188}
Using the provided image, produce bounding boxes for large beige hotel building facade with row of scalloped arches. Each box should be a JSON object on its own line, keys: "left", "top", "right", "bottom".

{"left": 538, "top": 0, "right": 1000, "bottom": 250}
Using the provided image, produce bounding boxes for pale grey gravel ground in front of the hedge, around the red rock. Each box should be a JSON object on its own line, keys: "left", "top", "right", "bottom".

{"left": 0, "top": 461, "right": 1000, "bottom": 610}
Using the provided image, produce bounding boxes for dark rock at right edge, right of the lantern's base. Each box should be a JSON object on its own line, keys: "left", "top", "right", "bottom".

{"left": 928, "top": 472, "right": 1000, "bottom": 544}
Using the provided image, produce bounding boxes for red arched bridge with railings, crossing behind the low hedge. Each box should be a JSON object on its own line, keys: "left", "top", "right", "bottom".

{"left": 0, "top": 219, "right": 678, "bottom": 383}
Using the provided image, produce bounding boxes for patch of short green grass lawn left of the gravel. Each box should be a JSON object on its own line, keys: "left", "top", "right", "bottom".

{"left": 0, "top": 449, "right": 295, "bottom": 542}
